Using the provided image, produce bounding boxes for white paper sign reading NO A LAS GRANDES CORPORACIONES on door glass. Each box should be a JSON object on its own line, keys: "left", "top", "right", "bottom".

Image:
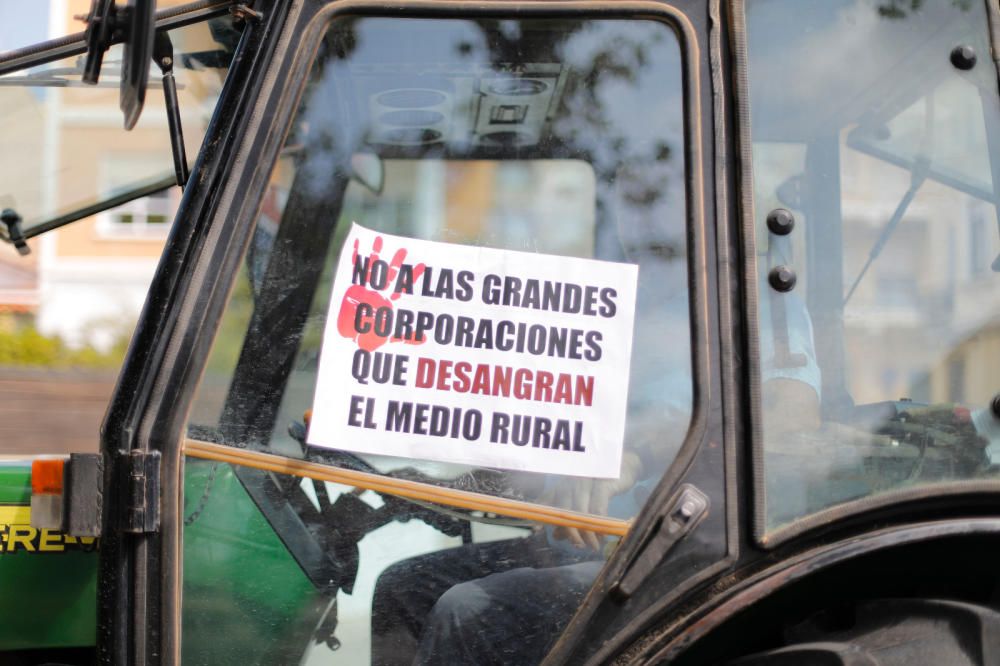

{"left": 308, "top": 224, "right": 638, "bottom": 478}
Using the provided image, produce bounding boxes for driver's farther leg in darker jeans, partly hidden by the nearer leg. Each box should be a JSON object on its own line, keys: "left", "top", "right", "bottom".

{"left": 371, "top": 534, "right": 573, "bottom": 666}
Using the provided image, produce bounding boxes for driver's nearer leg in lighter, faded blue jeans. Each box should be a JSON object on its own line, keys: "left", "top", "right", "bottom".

{"left": 413, "top": 560, "right": 604, "bottom": 666}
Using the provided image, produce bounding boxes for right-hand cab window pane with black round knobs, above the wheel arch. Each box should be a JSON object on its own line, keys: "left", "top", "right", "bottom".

{"left": 746, "top": 0, "right": 1000, "bottom": 529}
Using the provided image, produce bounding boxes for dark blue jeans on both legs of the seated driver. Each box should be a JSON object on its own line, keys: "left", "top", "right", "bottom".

{"left": 372, "top": 534, "right": 604, "bottom": 666}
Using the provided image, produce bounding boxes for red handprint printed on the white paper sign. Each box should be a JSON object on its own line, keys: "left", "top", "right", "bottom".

{"left": 337, "top": 236, "right": 424, "bottom": 351}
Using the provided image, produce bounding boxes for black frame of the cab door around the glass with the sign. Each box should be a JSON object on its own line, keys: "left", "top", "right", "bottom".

{"left": 102, "top": 0, "right": 739, "bottom": 663}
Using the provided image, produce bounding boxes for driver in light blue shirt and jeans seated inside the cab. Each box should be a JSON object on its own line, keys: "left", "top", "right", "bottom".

{"left": 371, "top": 231, "right": 820, "bottom": 666}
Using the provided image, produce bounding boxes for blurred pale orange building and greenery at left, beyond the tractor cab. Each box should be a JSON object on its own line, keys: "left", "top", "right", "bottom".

{"left": 0, "top": 0, "right": 225, "bottom": 454}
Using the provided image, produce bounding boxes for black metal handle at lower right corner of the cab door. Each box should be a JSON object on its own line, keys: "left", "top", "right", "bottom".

{"left": 611, "top": 484, "right": 708, "bottom": 601}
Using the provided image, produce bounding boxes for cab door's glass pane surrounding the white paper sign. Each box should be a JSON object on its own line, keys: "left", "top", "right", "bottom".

{"left": 184, "top": 18, "right": 693, "bottom": 663}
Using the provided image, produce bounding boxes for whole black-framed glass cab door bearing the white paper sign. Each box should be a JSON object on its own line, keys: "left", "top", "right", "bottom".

{"left": 102, "top": 2, "right": 731, "bottom": 664}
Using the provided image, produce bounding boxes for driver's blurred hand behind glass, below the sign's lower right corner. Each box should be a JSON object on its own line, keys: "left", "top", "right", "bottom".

{"left": 542, "top": 451, "right": 641, "bottom": 552}
